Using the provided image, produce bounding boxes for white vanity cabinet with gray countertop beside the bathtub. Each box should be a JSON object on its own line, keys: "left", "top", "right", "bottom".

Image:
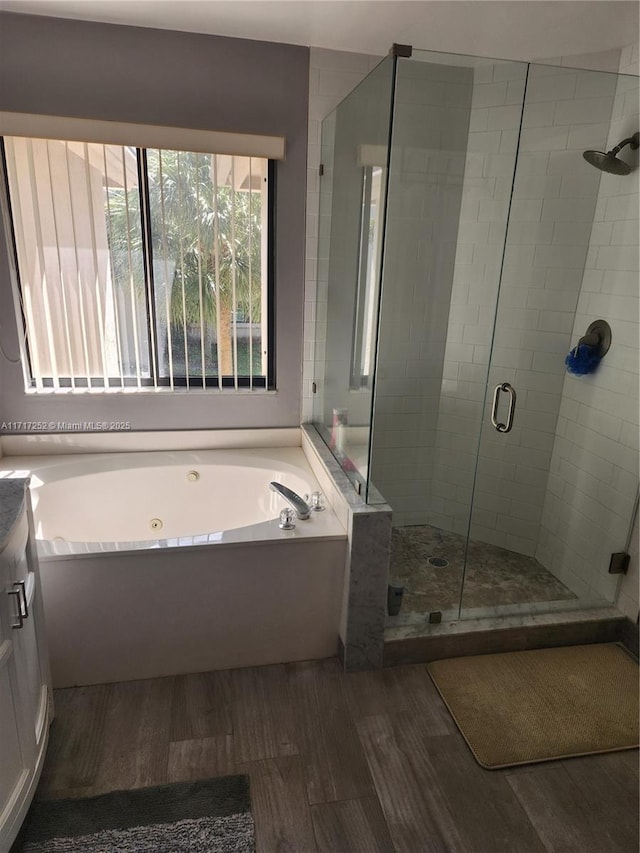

{"left": 0, "top": 479, "right": 52, "bottom": 853}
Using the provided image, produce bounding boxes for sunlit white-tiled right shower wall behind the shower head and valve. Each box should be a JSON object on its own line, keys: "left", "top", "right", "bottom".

{"left": 536, "top": 45, "right": 640, "bottom": 604}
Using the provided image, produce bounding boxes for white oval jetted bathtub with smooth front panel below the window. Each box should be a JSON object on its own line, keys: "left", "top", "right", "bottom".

{"left": 0, "top": 447, "right": 346, "bottom": 687}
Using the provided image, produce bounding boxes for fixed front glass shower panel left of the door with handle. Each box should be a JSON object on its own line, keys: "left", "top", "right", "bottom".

{"left": 370, "top": 50, "right": 527, "bottom": 623}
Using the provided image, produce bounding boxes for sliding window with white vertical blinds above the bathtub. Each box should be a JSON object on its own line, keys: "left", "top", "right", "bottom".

{"left": 4, "top": 136, "right": 274, "bottom": 391}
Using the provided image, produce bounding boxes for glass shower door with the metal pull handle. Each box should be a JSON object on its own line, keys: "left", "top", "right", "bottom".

{"left": 460, "top": 65, "right": 638, "bottom": 618}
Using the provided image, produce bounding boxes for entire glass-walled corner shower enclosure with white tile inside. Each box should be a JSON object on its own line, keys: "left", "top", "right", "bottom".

{"left": 313, "top": 46, "right": 638, "bottom": 625}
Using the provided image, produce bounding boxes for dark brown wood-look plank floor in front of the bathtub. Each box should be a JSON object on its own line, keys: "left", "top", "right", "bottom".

{"left": 27, "top": 660, "right": 638, "bottom": 853}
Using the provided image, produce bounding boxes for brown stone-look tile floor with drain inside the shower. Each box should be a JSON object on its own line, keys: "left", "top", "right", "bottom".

{"left": 391, "top": 525, "right": 576, "bottom": 615}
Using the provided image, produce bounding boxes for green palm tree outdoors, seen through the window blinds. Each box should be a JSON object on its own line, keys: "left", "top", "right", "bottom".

{"left": 107, "top": 149, "right": 262, "bottom": 376}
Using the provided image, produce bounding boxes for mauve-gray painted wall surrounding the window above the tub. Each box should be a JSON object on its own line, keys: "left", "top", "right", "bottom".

{"left": 0, "top": 12, "right": 309, "bottom": 430}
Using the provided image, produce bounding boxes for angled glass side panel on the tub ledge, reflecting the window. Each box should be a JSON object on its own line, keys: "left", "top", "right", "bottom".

{"left": 313, "top": 57, "right": 394, "bottom": 496}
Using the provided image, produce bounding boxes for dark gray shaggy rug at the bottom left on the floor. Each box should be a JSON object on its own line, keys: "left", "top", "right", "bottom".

{"left": 15, "top": 776, "right": 255, "bottom": 853}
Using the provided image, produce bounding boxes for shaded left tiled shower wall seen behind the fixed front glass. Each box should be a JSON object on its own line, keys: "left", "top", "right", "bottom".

{"left": 370, "top": 59, "right": 473, "bottom": 525}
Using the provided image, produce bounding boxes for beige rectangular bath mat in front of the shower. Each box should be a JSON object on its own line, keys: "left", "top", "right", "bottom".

{"left": 427, "top": 643, "right": 638, "bottom": 769}
